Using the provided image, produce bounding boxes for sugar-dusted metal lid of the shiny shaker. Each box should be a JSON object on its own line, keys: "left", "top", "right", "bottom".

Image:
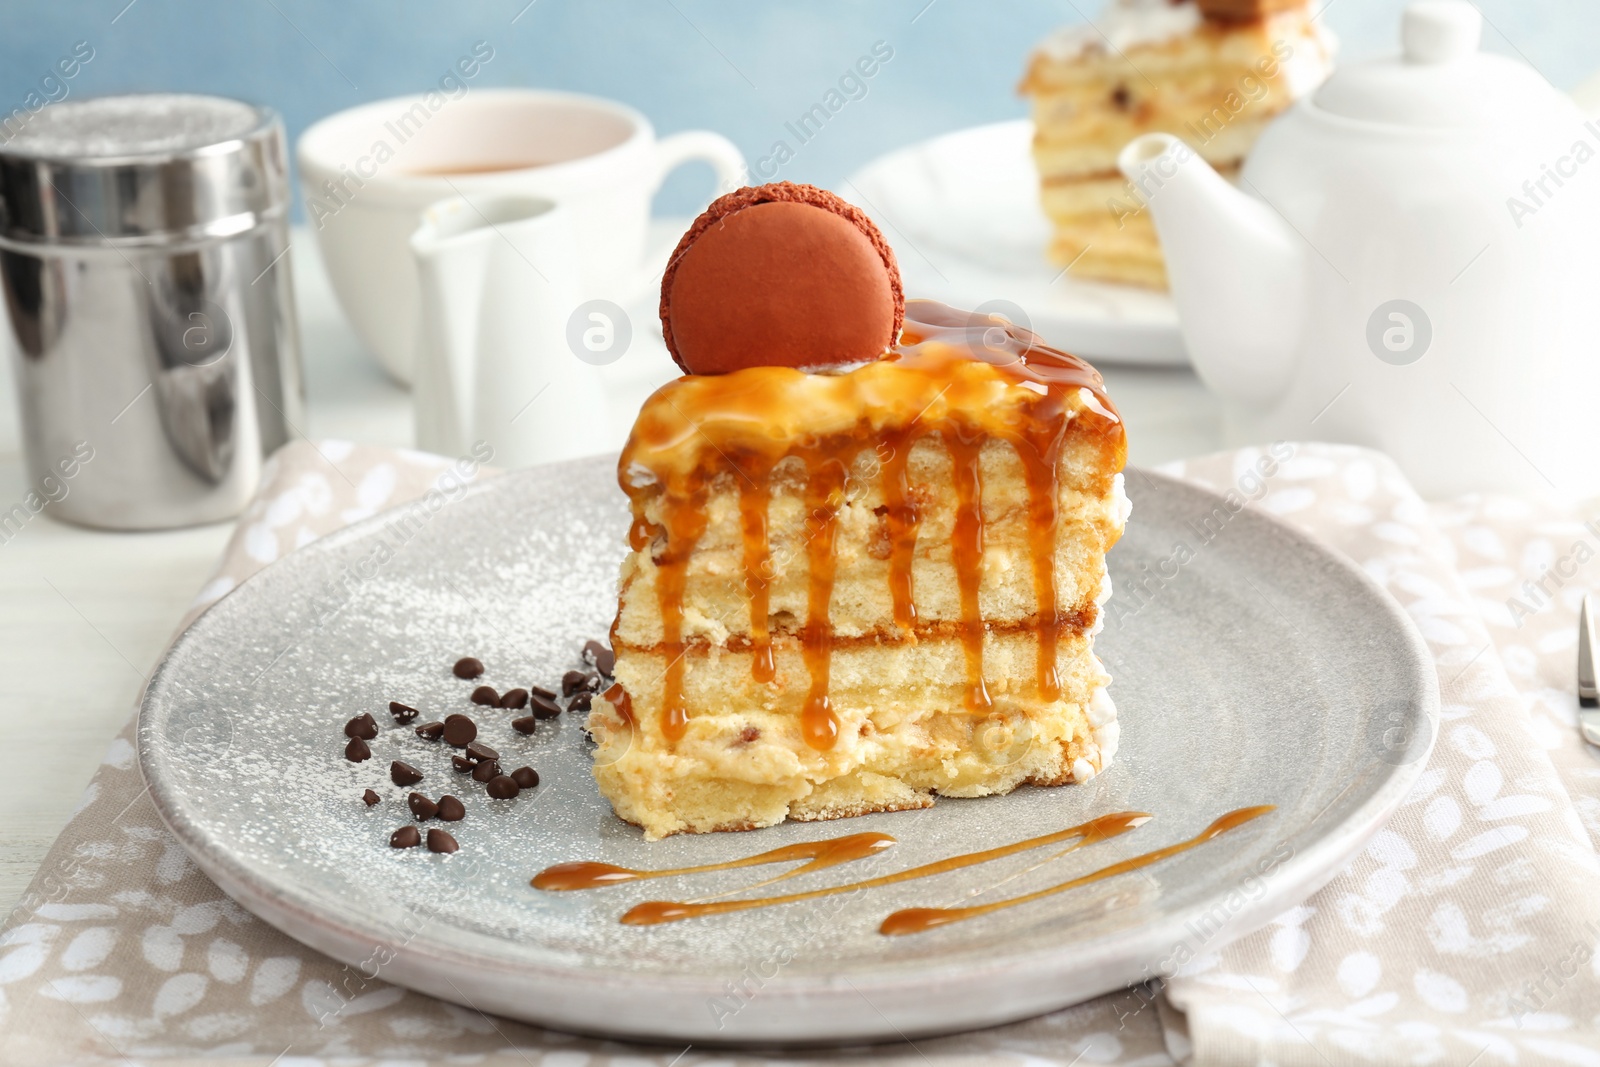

{"left": 0, "top": 93, "right": 290, "bottom": 246}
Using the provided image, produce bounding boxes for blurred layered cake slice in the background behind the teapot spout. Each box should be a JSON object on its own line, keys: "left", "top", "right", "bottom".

{"left": 1021, "top": 0, "right": 1333, "bottom": 288}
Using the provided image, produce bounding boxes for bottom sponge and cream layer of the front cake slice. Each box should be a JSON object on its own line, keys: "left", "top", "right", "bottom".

{"left": 589, "top": 630, "right": 1117, "bottom": 840}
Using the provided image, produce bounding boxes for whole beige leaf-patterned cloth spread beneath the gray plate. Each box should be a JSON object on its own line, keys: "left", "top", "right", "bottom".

{"left": 0, "top": 442, "right": 1600, "bottom": 1067}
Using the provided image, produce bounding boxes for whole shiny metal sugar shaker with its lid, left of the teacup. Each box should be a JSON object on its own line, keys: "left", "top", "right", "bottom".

{"left": 0, "top": 93, "right": 302, "bottom": 530}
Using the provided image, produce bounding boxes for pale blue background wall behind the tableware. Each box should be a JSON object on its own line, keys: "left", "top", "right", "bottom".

{"left": 0, "top": 0, "right": 1600, "bottom": 211}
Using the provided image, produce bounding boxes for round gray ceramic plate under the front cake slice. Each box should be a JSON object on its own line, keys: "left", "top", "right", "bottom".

{"left": 139, "top": 459, "right": 1438, "bottom": 1043}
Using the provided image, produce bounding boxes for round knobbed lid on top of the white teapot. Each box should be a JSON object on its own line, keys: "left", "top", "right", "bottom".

{"left": 1312, "top": 0, "right": 1571, "bottom": 130}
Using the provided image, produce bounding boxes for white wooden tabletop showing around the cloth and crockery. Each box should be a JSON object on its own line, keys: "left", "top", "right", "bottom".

{"left": 0, "top": 221, "right": 1221, "bottom": 915}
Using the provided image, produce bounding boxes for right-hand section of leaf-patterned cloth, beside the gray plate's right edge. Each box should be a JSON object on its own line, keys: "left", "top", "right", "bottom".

{"left": 1162, "top": 445, "right": 1600, "bottom": 1065}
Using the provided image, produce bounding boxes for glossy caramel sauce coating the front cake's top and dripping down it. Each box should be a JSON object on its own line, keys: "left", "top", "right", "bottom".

{"left": 608, "top": 301, "right": 1123, "bottom": 750}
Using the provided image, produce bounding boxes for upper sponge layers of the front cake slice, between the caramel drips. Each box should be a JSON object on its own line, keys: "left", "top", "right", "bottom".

{"left": 614, "top": 437, "right": 1123, "bottom": 648}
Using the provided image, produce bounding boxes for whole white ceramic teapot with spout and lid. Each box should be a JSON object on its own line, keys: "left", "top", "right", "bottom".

{"left": 1120, "top": 0, "right": 1600, "bottom": 498}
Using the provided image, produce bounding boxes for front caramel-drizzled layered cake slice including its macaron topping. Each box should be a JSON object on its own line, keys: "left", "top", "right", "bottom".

{"left": 590, "top": 182, "right": 1128, "bottom": 838}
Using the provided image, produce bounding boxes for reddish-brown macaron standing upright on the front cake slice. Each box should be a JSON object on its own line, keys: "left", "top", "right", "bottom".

{"left": 661, "top": 182, "right": 906, "bottom": 374}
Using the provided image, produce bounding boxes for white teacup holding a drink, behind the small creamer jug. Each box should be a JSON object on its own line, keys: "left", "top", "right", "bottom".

{"left": 298, "top": 90, "right": 746, "bottom": 382}
